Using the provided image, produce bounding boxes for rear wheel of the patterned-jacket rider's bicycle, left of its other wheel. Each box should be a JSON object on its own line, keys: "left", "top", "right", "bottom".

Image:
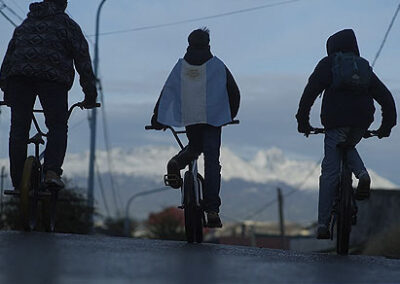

{"left": 20, "top": 156, "right": 39, "bottom": 231}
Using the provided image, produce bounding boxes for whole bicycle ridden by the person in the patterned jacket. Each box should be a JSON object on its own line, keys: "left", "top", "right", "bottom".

{"left": 0, "top": 102, "right": 100, "bottom": 232}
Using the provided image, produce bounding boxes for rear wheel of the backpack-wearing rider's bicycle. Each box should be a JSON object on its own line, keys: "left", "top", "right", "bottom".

{"left": 336, "top": 172, "right": 353, "bottom": 255}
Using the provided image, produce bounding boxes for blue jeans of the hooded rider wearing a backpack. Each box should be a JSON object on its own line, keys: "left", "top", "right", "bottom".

{"left": 318, "top": 127, "right": 368, "bottom": 225}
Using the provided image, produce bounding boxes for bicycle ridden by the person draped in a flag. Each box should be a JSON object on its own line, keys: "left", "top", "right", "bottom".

{"left": 145, "top": 120, "right": 239, "bottom": 243}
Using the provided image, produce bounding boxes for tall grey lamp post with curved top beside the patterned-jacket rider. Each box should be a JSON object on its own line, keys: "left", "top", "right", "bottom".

{"left": 87, "top": 0, "right": 106, "bottom": 227}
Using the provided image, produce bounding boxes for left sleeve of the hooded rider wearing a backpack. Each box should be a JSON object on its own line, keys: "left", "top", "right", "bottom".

{"left": 296, "top": 57, "right": 332, "bottom": 123}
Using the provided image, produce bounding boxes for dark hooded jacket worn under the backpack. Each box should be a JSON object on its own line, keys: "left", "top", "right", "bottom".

{"left": 296, "top": 30, "right": 396, "bottom": 129}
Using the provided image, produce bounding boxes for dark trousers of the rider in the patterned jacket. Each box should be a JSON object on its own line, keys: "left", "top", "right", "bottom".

{"left": 8, "top": 76, "right": 68, "bottom": 188}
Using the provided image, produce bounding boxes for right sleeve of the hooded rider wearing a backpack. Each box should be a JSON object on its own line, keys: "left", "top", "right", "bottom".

{"left": 369, "top": 73, "right": 397, "bottom": 129}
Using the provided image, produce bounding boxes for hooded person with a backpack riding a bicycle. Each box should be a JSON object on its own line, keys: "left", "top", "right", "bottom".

{"left": 296, "top": 29, "right": 397, "bottom": 239}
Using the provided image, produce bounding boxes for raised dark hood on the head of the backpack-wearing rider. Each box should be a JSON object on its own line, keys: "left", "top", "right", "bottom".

{"left": 326, "top": 29, "right": 360, "bottom": 56}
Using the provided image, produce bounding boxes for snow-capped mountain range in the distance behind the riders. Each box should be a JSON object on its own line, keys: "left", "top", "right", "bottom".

{"left": 57, "top": 146, "right": 398, "bottom": 190}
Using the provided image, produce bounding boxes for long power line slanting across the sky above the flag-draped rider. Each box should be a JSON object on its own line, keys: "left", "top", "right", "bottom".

{"left": 89, "top": 0, "right": 301, "bottom": 37}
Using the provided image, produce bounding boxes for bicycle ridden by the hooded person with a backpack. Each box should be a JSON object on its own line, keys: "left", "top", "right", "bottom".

{"left": 306, "top": 128, "right": 377, "bottom": 255}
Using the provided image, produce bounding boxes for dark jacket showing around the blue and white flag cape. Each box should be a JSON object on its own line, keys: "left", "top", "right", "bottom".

{"left": 152, "top": 46, "right": 240, "bottom": 124}
